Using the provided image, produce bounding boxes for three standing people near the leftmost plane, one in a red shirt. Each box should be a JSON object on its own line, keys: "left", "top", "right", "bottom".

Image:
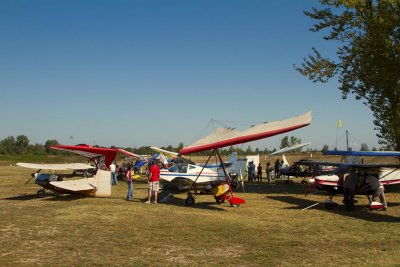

{"left": 109, "top": 158, "right": 160, "bottom": 204}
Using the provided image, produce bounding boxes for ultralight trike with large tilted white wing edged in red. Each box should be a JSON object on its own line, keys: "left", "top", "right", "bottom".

{"left": 179, "top": 112, "right": 311, "bottom": 207}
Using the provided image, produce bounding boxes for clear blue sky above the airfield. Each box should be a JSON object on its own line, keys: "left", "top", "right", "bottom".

{"left": 0, "top": 0, "right": 379, "bottom": 152}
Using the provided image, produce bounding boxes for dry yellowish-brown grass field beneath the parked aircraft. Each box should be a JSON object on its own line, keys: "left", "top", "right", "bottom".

{"left": 0, "top": 158, "right": 400, "bottom": 266}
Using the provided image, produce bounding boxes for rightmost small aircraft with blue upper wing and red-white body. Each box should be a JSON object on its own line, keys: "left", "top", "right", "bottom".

{"left": 304, "top": 151, "right": 400, "bottom": 210}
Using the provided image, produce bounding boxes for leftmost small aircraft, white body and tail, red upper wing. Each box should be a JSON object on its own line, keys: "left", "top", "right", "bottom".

{"left": 17, "top": 144, "right": 145, "bottom": 197}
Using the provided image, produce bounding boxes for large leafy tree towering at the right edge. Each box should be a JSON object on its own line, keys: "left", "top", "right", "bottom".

{"left": 295, "top": 0, "right": 400, "bottom": 150}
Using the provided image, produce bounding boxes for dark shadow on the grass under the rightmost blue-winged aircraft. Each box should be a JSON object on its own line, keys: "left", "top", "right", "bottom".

{"left": 266, "top": 196, "right": 400, "bottom": 223}
